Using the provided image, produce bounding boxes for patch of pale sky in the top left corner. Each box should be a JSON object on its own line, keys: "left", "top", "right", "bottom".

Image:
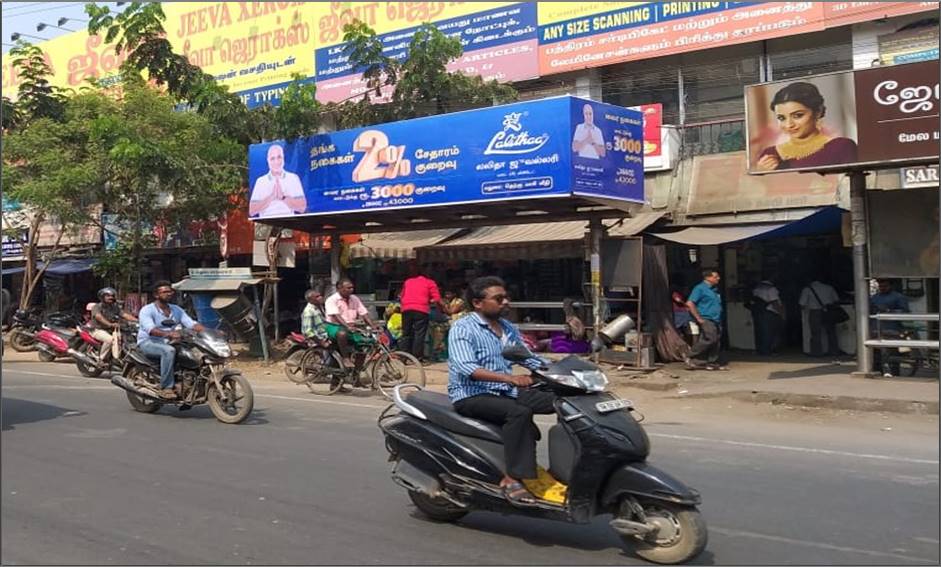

{"left": 0, "top": 1, "right": 121, "bottom": 53}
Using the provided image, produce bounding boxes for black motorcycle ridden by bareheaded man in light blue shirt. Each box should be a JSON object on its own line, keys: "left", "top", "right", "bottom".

{"left": 111, "top": 319, "right": 254, "bottom": 424}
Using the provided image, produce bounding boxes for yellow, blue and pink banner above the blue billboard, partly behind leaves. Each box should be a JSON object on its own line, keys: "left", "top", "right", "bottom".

{"left": 314, "top": 2, "right": 538, "bottom": 102}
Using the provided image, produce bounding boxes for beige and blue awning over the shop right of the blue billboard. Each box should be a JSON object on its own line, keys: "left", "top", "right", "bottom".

{"left": 649, "top": 207, "right": 842, "bottom": 246}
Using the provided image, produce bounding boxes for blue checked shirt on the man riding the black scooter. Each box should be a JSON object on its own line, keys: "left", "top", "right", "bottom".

{"left": 448, "top": 313, "right": 542, "bottom": 403}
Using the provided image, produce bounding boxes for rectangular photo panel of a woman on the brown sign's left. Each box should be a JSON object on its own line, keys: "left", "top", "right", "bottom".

{"left": 745, "top": 74, "right": 857, "bottom": 173}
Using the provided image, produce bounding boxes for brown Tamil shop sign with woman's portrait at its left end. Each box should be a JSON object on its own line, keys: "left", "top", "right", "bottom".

{"left": 745, "top": 60, "right": 941, "bottom": 174}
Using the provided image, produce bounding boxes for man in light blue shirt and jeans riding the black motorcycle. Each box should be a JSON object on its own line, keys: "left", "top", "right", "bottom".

{"left": 137, "top": 281, "right": 205, "bottom": 399}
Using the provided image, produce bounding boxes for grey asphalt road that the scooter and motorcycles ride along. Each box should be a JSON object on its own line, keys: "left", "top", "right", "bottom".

{"left": 0, "top": 362, "right": 939, "bottom": 565}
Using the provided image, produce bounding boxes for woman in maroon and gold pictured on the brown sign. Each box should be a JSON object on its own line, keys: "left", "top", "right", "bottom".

{"left": 756, "top": 82, "right": 856, "bottom": 171}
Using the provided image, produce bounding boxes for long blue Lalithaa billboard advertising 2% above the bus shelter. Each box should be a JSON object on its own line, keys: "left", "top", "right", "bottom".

{"left": 249, "top": 97, "right": 644, "bottom": 218}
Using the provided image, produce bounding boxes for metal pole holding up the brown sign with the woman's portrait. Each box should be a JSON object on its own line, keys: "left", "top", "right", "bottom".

{"left": 850, "top": 171, "right": 872, "bottom": 375}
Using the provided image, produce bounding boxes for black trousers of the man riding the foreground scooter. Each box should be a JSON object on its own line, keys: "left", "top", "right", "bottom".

{"left": 454, "top": 389, "right": 556, "bottom": 480}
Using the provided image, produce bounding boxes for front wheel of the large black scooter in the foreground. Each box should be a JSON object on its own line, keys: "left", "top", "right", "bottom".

{"left": 621, "top": 502, "right": 708, "bottom": 565}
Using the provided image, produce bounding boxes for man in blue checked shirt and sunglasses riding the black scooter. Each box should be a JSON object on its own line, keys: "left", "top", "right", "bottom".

{"left": 448, "top": 277, "right": 555, "bottom": 504}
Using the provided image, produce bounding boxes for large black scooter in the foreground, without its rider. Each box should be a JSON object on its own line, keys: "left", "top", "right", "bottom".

{"left": 379, "top": 347, "right": 707, "bottom": 564}
